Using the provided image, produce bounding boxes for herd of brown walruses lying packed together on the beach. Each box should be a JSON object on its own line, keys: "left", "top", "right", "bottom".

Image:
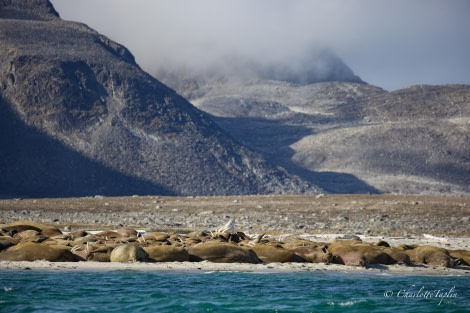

{"left": 0, "top": 221, "right": 470, "bottom": 267}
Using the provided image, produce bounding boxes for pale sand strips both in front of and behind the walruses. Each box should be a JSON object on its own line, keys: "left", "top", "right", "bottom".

{"left": 0, "top": 230, "right": 470, "bottom": 277}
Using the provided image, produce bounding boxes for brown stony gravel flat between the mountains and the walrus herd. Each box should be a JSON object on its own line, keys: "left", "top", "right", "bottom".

{"left": 0, "top": 195, "right": 470, "bottom": 237}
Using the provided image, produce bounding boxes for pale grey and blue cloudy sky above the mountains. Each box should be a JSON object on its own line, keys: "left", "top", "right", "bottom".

{"left": 52, "top": 0, "right": 470, "bottom": 90}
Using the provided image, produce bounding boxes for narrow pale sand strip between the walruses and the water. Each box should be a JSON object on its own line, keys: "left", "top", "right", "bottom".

{"left": 0, "top": 261, "right": 470, "bottom": 277}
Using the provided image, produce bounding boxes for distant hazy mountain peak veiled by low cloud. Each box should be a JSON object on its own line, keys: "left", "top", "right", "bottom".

{"left": 154, "top": 48, "right": 366, "bottom": 99}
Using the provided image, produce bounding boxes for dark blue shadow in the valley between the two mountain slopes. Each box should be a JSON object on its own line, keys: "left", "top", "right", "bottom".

{"left": 212, "top": 116, "right": 381, "bottom": 194}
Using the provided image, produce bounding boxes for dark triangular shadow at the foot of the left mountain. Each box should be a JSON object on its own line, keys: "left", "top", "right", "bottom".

{"left": 0, "top": 98, "right": 174, "bottom": 198}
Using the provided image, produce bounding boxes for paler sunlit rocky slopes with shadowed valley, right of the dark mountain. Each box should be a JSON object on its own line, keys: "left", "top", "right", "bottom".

{"left": 159, "top": 69, "right": 470, "bottom": 194}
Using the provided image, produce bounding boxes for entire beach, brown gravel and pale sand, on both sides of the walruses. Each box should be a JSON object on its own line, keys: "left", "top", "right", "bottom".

{"left": 0, "top": 195, "right": 470, "bottom": 275}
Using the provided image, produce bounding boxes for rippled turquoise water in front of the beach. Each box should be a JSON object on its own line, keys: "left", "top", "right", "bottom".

{"left": 0, "top": 270, "right": 470, "bottom": 313}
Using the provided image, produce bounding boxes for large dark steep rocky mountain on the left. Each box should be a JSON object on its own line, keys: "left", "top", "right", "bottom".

{"left": 0, "top": 0, "right": 321, "bottom": 197}
